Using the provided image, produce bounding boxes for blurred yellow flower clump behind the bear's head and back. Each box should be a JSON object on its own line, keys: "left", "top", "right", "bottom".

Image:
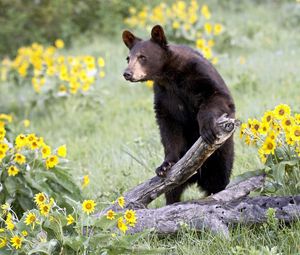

{"left": 125, "top": 0, "right": 223, "bottom": 64}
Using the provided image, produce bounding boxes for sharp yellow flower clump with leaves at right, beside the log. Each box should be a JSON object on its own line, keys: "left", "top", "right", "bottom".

{"left": 240, "top": 104, "right": 300, "bottom": 194}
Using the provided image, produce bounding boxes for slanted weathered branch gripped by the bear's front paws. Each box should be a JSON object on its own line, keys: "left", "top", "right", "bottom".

{"left": 100, "top": 115, "right": 239, "bottom": 215}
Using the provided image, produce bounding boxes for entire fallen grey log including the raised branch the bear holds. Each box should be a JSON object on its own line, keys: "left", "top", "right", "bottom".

{"left": 95, "top": 116, "right": 300, "bottom": 238}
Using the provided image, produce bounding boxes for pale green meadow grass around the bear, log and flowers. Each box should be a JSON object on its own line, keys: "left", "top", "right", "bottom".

{"left": 0, "top": 1, "right": 300, "bottom": 254}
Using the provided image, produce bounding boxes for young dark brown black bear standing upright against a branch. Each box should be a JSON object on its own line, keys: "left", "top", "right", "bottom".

{"left": 122, "top": 25, "right": 235, "bottom": 204}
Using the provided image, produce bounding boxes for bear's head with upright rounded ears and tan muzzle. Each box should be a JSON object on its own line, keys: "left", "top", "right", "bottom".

{"left": 122, "top": 25, "right": 168, "bottom": 82}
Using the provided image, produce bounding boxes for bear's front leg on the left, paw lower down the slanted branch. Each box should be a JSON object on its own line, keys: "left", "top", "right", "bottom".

{"left": 155, "top": 117, "right": 187, "bottom": 177}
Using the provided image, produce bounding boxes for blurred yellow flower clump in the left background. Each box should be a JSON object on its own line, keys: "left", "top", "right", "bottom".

{"left": 0, "top": 39, "right": 105, "bottom": 99}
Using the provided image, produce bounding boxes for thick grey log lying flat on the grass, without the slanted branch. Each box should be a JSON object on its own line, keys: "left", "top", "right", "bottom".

{"left": 130, "top": 175, "right": 300, "bottom": 238}
